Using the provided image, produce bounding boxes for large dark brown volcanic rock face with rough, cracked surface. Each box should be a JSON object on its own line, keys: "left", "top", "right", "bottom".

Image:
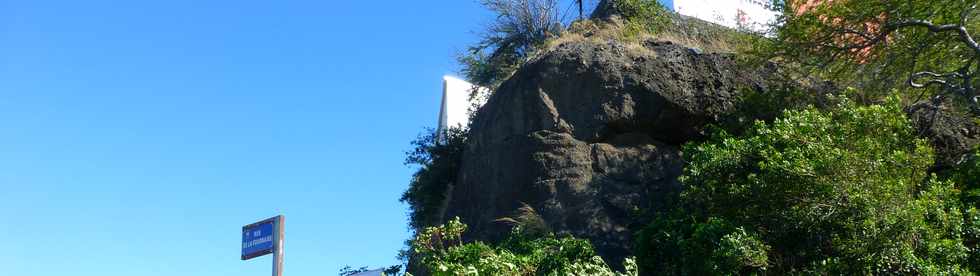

{"left": 443, "top": 39, "right": 772, "bottom": 264}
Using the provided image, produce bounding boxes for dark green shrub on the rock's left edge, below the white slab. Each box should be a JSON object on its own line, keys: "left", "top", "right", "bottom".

{"left": 401, "top": 128, "right": 467, "bottom": 230}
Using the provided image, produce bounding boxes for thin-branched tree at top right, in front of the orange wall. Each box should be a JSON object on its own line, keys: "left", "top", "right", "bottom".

{"left": 760, "top": 0, "right": 980, "bottom": 108}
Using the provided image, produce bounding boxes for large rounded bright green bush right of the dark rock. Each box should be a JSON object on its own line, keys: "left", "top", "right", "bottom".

{"left": 638, "top": 97, "right": 968, "bottom": 275}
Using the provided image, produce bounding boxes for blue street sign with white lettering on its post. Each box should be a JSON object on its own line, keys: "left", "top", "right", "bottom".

{"left": 242, "top": 215, "right": 286, "bottom": 276}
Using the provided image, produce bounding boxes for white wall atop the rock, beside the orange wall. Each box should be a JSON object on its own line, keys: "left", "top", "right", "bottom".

{"left": 674, "top": 0, "right": 777, "bottom": 32}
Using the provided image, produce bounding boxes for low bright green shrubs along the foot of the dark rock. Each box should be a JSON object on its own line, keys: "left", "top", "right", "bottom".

{"left": 411, "top": 218, "right": 636, "bottom": 276}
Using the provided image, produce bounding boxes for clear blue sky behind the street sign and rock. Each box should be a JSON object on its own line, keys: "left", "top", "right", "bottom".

{"left": 0, "top": 0, "right": 668, "bottom": 276}
